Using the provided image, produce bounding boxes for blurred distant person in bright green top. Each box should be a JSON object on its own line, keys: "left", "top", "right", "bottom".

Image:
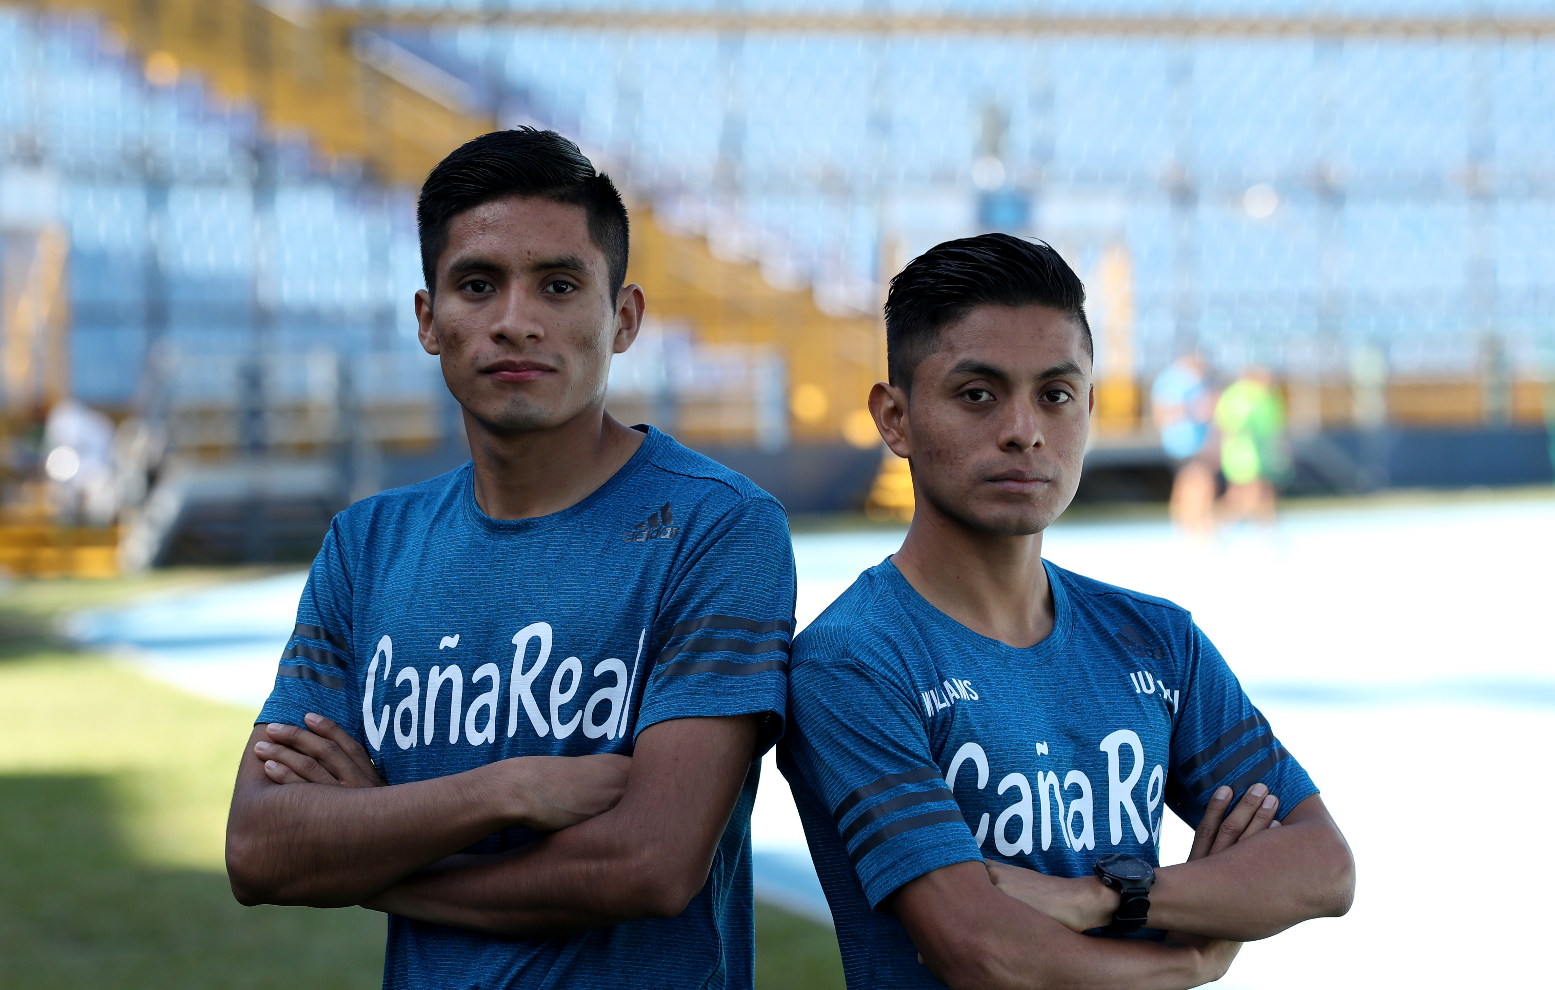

{"left": 1214, "top": 367, "right": 1291, "bottom": 522}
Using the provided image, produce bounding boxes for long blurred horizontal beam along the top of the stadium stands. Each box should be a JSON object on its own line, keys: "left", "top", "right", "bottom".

{"left": 346, "top": 6, "right": 1555, "bottom": 40}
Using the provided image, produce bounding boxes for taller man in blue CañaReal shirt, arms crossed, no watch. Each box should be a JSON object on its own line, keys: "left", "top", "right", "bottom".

{"left": 227, "top": 129, "right": 795, "bottom": 988}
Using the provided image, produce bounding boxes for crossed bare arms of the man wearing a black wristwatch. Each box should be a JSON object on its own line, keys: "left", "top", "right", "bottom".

{"left": 888, "top": 785, "right": 1354, "bottom": 990}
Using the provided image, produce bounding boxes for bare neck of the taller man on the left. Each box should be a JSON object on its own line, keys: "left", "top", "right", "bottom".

{"left": 463, "top": 404, "right": 644, "bottom": 519}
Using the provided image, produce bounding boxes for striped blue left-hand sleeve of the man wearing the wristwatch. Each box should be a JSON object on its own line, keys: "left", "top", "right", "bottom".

{"left": 785, "top": 659, "right": 983, "bottom": 908}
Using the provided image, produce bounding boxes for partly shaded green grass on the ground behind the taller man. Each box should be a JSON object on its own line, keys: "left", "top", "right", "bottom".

{"left": 0, "top": 572, "right": 843, "bottom": 990}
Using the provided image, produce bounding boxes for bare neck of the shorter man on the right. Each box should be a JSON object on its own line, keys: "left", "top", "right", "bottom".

{"left": 891, "top": 497, "right": 1053, "bottom": 650}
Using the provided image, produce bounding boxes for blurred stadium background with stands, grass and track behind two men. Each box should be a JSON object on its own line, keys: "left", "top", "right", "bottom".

{"left": 0, "top": 0, "right": 1555, "bottom": 987}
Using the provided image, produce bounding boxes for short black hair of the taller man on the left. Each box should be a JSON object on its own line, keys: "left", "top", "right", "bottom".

{"left": 415, "top": 127, "right": 628, "bottom": 300}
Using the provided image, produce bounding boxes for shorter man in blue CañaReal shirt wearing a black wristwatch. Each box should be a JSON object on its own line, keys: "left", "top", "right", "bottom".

{"left": 779, "top": 235, "right": 1354, "bottom": 990}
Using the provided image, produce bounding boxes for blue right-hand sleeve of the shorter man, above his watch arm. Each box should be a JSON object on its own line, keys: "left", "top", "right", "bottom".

{"left": 1166, "top": 625, "right": 1317, "bottom": 825}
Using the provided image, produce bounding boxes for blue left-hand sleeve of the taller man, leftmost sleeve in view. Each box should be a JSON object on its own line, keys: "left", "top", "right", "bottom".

{"left": 255, "top": 525, "right": 362, "bottom": 738}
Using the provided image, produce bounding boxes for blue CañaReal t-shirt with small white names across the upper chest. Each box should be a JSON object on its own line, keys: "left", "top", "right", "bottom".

{"left": 778, "top": 559, "right": 1317, "bottom": 988}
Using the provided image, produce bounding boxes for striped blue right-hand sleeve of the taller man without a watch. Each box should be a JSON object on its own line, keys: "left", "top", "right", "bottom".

{"left": 636, "top": 499, "right": 796, "bottom": 751}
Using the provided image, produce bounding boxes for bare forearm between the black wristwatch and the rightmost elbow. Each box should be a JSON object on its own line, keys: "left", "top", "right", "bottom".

{"left": 1149, "top": 794, "right": 1354, "bottom": 942}
